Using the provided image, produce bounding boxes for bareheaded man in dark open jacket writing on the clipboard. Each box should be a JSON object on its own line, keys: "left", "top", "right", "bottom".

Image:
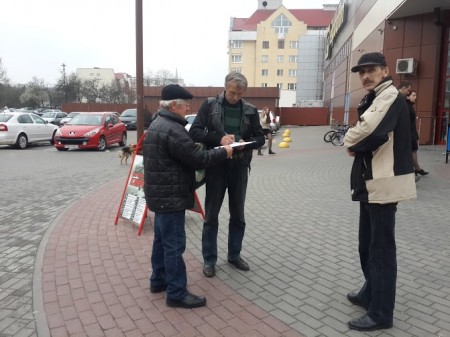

{"left": 189, "top": 72, "right": 264, "bottom": 277}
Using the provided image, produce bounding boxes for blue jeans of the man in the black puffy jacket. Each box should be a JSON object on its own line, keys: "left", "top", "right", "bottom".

{"left": 150, "top": 210, "right": 187, "bottom": 300}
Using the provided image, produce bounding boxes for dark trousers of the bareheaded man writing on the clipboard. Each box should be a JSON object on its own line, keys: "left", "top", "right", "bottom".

{"left": 202, "top": 158, "right": 248, "bottom": 265}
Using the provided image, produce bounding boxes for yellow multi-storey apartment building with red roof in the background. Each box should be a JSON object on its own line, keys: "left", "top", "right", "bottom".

{"left": 228, "top": 0, "right": 336, "bottom": 106}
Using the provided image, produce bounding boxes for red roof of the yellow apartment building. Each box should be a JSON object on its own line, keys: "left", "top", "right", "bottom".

{"left": 231, "top": 9, "right": 335, "bottom": 31}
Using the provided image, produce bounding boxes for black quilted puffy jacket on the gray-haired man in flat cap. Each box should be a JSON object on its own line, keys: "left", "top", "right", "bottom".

{"left": 143, "top": 109, "right": 227, "bottom": 212}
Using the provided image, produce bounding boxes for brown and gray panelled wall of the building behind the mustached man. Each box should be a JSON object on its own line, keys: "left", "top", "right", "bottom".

{"left": 324, "top": 0, "right": 444, "bottom": 144}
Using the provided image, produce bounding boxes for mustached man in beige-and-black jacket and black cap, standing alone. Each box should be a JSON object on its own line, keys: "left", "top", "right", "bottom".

{"left": 344, "top": 53, "right": 416, "bottom": 331}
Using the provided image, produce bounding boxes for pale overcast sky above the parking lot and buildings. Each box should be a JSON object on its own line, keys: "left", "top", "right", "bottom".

{"left": 0, "top": 0, "right": 339, "bottom": 86}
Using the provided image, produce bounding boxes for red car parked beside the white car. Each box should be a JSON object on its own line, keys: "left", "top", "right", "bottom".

{"left": 55, "top": 112, "right": 127, "bottom": 151}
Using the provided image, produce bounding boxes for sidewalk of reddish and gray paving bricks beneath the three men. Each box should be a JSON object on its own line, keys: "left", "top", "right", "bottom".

{"left": 33, "top": 127, "right": 450, "bottom": 337}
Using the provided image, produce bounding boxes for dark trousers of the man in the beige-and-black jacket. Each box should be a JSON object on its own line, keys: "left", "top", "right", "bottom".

{"left": 358, "top": 202, "right": 397, "bottom": 324}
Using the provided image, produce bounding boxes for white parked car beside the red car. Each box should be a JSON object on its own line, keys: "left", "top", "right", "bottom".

{"left": 0, "top": 112, "right": 59, "bottom": 149}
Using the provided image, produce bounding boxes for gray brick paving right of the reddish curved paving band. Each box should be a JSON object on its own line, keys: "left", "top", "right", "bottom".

{"left": 187, "top": 127, "right": 450, "bottom": 337}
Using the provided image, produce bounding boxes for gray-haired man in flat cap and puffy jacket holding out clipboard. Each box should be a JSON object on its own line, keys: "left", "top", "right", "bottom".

{"left": 143, "top": 84, "right": 233, "bottom": 308}
